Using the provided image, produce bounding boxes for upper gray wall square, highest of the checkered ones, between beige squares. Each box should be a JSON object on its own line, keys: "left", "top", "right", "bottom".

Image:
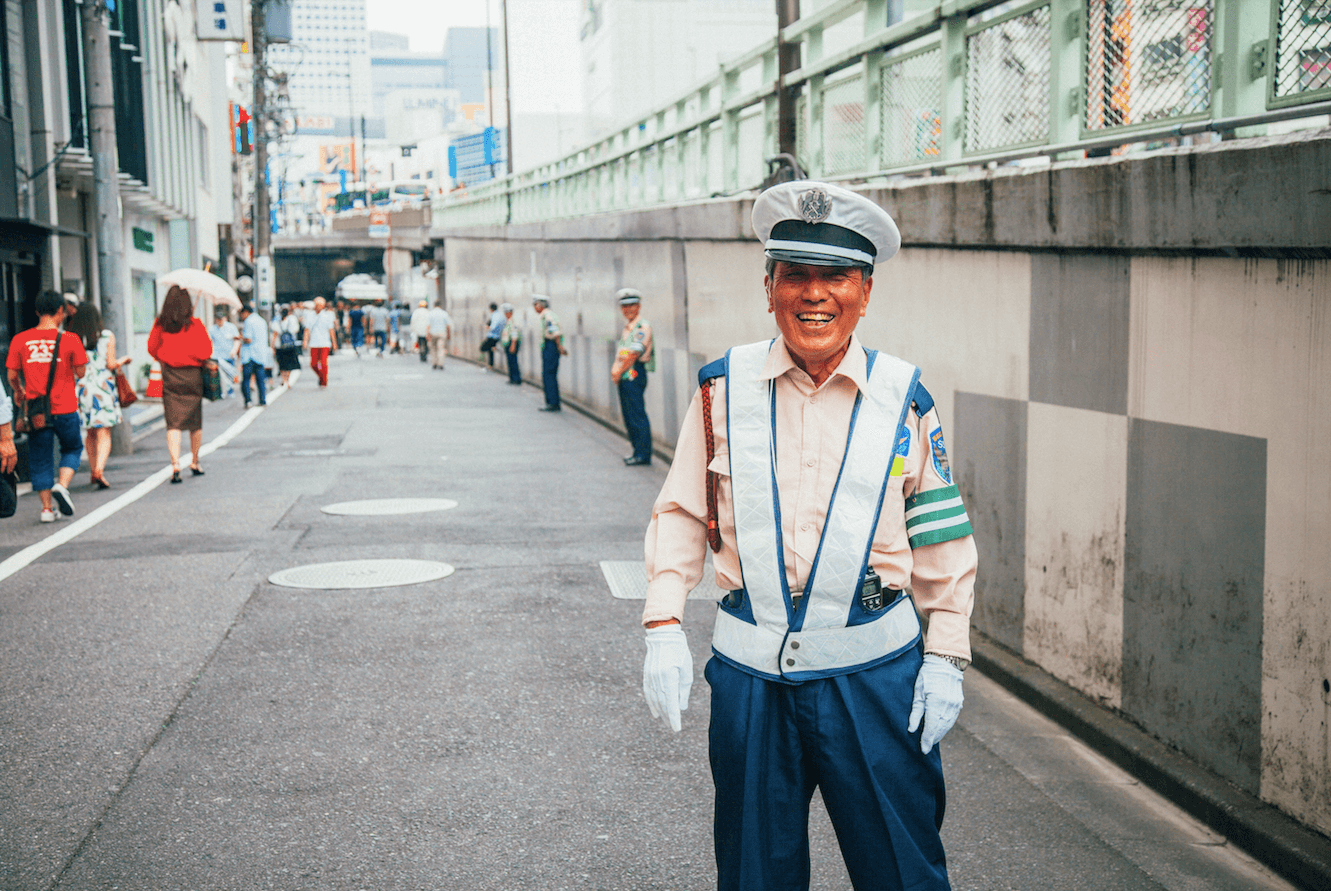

{"left": 1030, "top": 254, "right": 1131, "bottom": 414}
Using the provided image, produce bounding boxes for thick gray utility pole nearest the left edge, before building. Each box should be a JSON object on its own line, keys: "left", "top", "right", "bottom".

{"left": 79, "top": 0, "right": 134, "bottom": 454}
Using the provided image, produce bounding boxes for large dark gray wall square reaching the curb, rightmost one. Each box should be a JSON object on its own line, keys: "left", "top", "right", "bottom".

{"left": 1123, "top": 420, "right": 1266, "bottom": 794}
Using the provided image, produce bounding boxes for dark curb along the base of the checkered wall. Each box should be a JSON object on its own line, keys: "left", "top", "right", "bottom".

{"left": 970, "top": 629, "right": 1331, "bottom": 891}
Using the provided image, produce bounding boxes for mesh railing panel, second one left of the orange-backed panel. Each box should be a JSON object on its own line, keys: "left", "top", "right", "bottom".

{"left": 880, "top": 48, "right": 942, "bottom": 166}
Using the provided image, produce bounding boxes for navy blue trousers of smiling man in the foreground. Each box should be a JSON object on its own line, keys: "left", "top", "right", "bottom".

{"left": 704, "top": 647, "right": 952, "bottom": 891}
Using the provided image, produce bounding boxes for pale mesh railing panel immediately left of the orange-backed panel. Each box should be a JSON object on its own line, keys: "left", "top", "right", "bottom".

{"left": 965, "top": 7, "right": 1050, "bottom": 152}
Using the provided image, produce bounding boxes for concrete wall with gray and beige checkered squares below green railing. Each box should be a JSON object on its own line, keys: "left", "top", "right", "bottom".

{"left": 439, "top": 132, "right": 1331, "bottom": 832}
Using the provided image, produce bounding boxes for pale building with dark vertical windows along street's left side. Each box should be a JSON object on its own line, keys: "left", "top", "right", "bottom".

{"left": 0, "top": 0, "right": 238, "bottom": 372}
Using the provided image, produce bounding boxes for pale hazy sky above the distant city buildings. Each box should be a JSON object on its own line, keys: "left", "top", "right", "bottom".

{"left": 366, "top": 0, "right": 583, "bottom": 113}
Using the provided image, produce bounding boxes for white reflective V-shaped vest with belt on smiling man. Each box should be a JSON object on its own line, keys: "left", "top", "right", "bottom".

{"left": 712, "top": 341, "right": 920, "bottom": 682}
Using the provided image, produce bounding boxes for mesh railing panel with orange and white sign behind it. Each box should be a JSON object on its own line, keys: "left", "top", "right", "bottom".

{"left": 1086, "top": 0, "right": 1215, "bottom": 131}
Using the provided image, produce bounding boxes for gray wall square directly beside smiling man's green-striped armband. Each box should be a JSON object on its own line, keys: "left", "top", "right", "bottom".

{"left": 945, "top": 392, "right": 1026, "bottom": 653}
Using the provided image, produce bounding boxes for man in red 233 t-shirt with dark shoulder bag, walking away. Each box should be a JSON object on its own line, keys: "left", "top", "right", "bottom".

{"left": 5, "top": 290, "right": 88, "bottom": 523}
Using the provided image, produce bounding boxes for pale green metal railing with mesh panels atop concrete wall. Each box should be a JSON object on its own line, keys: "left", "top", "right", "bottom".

{"left": 433, "top": 0, "right": 1331, "bottom": 228}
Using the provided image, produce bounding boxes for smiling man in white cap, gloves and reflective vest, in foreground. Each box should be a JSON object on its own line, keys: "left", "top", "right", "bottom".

{"left": 643, "top": 181, "right": 977, "bottom": 891}
